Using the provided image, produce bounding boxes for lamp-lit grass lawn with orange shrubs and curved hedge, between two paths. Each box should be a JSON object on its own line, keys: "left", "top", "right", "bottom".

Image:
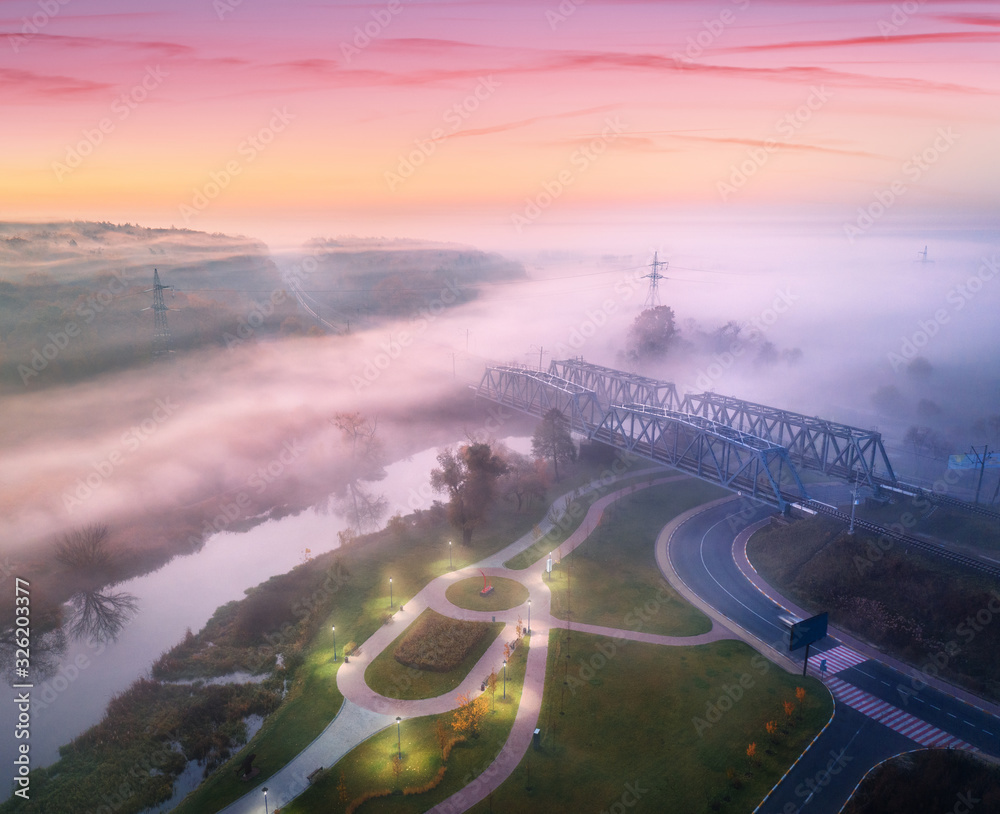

{"left": 281, "top": 636, "right": 529, "bottom": 814}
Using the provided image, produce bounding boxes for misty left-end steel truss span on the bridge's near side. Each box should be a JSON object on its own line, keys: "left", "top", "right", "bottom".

{"left": 477, "top": 365, "right": 604, "bottom": 438}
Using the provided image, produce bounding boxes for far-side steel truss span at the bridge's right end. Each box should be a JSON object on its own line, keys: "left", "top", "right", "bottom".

{"left": 685, "top": 393, "right": 896, "bottom": 491}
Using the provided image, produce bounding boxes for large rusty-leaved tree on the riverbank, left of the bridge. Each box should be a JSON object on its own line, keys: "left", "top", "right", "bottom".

{"left": 431, "top": 443, "right": 507, "bottom": 545}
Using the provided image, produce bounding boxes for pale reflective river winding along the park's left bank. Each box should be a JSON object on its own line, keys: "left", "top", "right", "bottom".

{"left": 0, "top": 438, "right": 530, "bottom": 796}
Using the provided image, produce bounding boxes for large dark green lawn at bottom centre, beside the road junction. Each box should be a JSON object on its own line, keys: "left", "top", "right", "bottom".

{"left": 470, "top": 631, "right": 832, "bottom": 814}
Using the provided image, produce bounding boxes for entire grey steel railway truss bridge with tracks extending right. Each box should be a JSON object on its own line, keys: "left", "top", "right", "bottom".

{"left": 477, "top": 358, "right": 1000, "bottom": 577}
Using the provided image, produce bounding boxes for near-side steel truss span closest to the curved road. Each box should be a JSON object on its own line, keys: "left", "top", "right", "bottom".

{"left": 591, "top": 404, "right": 809, "bottom": 511}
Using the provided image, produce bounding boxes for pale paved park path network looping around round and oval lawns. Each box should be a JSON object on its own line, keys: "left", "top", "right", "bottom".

{"left": 221, "top": 469, "right": 733, "bottom": 814}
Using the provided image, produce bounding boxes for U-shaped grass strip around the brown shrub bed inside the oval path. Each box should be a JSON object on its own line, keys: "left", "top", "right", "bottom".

{"left": 365, "top": 608, "right": 504, "bottom": 701}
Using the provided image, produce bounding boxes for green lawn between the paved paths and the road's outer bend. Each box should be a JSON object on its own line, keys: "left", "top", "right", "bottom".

{"left": 550, "top": 478, "right": 726, "bottom": 636}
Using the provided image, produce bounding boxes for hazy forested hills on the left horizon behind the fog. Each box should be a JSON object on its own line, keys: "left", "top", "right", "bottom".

{"left": 0, "top": 222, "right": 524, "bottom": 387}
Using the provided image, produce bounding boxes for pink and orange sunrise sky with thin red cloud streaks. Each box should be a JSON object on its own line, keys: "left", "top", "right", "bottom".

{"left": 0, "top": 0, "right": 1000, "bottom": 249}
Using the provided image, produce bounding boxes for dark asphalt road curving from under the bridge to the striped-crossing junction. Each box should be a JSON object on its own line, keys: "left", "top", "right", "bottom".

{"left": 657, "top": 498, "right": 1000, "bottom": 814}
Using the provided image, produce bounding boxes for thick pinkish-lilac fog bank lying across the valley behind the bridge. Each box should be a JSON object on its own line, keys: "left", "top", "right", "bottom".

{"left": 0, "top": 220, "right": 1000, "bottom": 572}
